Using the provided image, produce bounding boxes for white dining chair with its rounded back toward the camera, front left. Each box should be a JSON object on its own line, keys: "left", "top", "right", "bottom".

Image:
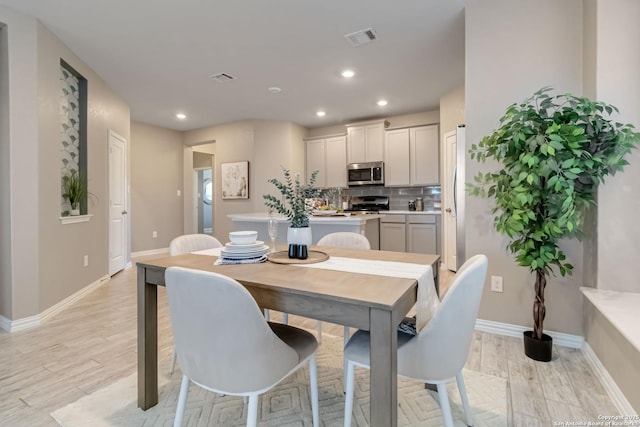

{"left": 165, "top": 267, "right": 319, "bottom": 427}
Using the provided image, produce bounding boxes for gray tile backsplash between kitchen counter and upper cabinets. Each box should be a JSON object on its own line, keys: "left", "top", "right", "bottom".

{"left": 320, "top": 185, "right": 441, "bottom": 210}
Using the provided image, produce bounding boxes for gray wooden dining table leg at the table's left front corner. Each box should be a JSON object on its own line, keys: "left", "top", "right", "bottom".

{"left": 138, "top": 267, "right": 158, "bottom": 410}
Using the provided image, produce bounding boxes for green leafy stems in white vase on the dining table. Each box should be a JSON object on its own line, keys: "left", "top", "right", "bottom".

{"left": 262, "top": 168, "right": 319, "bottom": 246}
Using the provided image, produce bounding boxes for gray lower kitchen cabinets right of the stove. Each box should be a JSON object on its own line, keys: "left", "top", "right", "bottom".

{"left": 380, "top": 214, "right": 440, "bottom": 255}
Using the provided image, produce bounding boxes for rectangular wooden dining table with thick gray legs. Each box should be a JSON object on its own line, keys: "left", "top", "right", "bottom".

{"left": 137, "top": 245, "right": 440, "bottom": 427}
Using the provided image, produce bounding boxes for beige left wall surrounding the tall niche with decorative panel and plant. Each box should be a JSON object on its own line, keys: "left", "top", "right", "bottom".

{"left": 37, "top": 20, "right": 130, "bottom": 311}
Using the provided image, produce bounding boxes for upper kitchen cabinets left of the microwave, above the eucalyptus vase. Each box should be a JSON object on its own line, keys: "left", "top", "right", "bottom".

{"left": 306, "top": 135, "right": 347, "bottom": 188}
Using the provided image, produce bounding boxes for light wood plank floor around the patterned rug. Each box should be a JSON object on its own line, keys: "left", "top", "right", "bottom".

{"left": 0, "top": 256, "right": 617, "bottom": 427}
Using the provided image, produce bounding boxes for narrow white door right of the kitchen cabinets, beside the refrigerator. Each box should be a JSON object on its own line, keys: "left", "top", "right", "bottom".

{"left": 442, "top": 131, "right": 457, "bottom": 271}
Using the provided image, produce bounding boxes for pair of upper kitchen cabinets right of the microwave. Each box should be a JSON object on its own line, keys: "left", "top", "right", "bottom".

{"left": 385, "top": 125, "right": 440, "bottom": 186}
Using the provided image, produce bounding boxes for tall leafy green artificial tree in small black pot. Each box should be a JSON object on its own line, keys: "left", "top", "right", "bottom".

{"left": 468, "top": 88, "right": 640, "bottom": 362}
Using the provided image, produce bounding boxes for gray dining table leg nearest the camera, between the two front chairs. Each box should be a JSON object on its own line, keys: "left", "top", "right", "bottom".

{"left": 369, "top": 308, "right": 398, "bottom": 427}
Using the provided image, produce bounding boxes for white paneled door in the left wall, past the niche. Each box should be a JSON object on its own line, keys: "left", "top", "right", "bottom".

{"left": 109, "top": 130, "right": 128, "bottom": 276}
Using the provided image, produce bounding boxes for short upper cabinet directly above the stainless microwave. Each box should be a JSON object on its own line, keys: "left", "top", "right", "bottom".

{"left": 347, "top": 120, "right": 389, "bottom": 163}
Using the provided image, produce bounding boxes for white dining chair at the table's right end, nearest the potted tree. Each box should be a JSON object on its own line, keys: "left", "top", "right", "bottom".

{"left": 344, "top": 255, "right": 487, "bottom": 427}
